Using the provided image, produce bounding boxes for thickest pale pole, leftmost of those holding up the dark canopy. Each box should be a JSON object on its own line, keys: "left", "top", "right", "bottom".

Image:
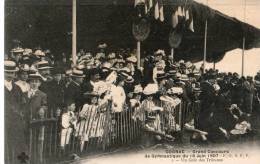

{"left": 72, "top": 0, "right": 77, "bottom": 66}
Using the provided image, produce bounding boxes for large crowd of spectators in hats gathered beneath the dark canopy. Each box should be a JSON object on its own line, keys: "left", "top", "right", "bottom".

{"left": 4, "top": 43, "right": 260, "bottom": 163}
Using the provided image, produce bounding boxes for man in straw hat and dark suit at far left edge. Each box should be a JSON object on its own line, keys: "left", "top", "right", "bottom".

{"left": 4, "top": 61, "right": 27, "bottom": 163}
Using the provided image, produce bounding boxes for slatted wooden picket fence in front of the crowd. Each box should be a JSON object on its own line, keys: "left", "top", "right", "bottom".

{"left": 6, "top": 99, "right": 201, "bottom": 164}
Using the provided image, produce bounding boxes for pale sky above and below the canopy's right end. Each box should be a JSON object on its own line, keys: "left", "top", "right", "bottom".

{"left": 195, "top": 0, "right": 260, "bottom": 76}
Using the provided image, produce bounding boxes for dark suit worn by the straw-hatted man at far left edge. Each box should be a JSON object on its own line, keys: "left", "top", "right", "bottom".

{"left": 4, "top": 83, "right": 28, "bottom": 163}
